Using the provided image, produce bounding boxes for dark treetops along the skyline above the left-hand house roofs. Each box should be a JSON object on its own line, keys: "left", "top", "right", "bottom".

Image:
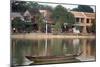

{"left": 11, "top": 1, "right": 52, "bottom": 12}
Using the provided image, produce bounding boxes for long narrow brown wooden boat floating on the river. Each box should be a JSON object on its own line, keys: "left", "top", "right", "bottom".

{"left": 25, "top": 52, "right": 82, "bottom": 62}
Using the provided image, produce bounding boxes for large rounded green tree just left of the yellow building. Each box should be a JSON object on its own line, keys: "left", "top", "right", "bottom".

{"left": 52, "top": 5, "right": 75, "bottom": 32}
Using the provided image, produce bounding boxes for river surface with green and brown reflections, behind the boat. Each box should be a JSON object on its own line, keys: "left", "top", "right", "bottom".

{"left": 12, "top": 39, "right": 96, "bottom": 65}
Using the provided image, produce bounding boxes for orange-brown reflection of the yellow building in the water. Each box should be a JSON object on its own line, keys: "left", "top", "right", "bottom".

{"left": 82, "top": 39, "right": 96, "bottom": 57}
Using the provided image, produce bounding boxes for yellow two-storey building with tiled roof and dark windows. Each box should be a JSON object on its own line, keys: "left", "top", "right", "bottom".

{"left": 71, "top": 11, "right": 96, "bottom": 33}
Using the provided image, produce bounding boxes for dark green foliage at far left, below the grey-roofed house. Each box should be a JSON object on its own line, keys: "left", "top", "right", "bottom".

{"left": 12, "top": 17, "right": 33, "bottom": 32}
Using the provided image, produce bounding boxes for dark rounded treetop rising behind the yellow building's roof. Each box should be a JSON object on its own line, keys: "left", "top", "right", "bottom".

{"left": 72, "top": 5, "right": 93, "bottom": 13}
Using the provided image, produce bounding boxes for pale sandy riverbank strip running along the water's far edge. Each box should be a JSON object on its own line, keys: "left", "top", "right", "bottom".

{"left": 11, "top": 33, "right": 96, "bottom": 39}
